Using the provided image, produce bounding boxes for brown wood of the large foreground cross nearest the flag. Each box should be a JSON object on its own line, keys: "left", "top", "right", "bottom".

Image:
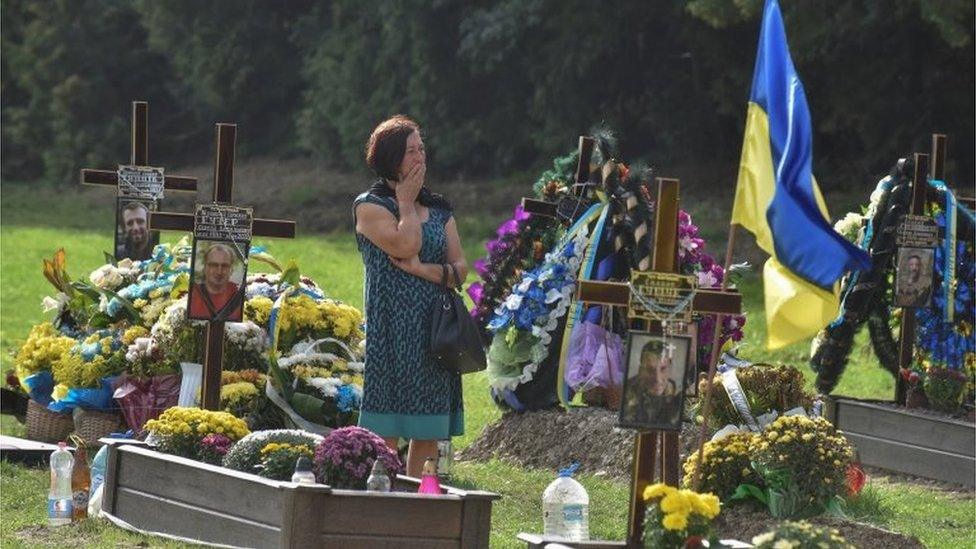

{"left": 576, "top": 178, "right": 742, "bottom": 546}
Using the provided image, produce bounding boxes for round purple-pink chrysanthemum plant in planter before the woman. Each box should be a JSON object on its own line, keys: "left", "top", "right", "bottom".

{"left": 314, "top": 426, "right": 403, "bottom": 490}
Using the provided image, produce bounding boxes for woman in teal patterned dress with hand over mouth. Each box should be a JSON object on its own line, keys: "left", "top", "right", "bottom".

{"left": 353, "top": 115, "right": 468, "bottom": 477}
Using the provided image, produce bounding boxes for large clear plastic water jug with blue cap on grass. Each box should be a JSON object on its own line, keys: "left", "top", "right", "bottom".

{"left": 542, "top": 463, "right": 590, "bottom": 541}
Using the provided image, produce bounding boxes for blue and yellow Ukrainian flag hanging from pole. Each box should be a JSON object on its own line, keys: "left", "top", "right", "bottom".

{"left": 732, "top": 0, "right": 870, "bottom": 349}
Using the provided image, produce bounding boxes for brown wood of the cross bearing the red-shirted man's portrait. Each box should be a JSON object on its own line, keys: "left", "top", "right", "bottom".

{"left": 149, "top": 124, "right": 295, "bottom": 410}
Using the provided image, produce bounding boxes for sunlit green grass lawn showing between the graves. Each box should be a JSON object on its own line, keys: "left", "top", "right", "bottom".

{"left": 0, "top": 185, "right": 976, "bottom": 547}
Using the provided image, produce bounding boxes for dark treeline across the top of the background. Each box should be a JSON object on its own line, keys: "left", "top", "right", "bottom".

{"left": 0, "top": 0, "right": 976, "bottom": 187}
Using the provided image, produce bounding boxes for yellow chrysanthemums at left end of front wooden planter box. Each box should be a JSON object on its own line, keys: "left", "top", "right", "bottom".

{"left": 145, "top": 406, "right": 250, "bottom": 460}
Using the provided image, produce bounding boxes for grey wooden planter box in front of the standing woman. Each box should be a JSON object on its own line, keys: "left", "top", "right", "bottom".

{"left": 102, "top": 444, "right": 500, "bottom": 549}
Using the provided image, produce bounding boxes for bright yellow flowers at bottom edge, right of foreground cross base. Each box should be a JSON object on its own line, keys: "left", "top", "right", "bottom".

{"left": 643, "top": 483, "right": 722, "bottom": 549}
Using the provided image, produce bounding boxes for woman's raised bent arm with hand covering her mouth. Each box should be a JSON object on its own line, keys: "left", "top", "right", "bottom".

{"left": 356, "top": 164, "right": 426, "bottom": 257}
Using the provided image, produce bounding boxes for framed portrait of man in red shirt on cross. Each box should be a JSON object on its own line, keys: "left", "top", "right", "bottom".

{"left": 186, "top": 239, "right": 248, "bottom": 322}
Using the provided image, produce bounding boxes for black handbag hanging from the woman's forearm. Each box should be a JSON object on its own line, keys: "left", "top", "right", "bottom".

{"left": 430, "top": 265, "right": 488, "bottom": 374}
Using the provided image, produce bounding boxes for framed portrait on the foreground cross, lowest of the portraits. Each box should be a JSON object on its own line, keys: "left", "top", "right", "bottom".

{"left": 618, "top": 332, "right": 692, "bottom": 431}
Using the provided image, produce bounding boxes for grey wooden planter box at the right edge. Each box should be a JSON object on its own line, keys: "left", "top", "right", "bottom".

{"left": 827, "top": 397, "right": 976, "bottom": 486}
